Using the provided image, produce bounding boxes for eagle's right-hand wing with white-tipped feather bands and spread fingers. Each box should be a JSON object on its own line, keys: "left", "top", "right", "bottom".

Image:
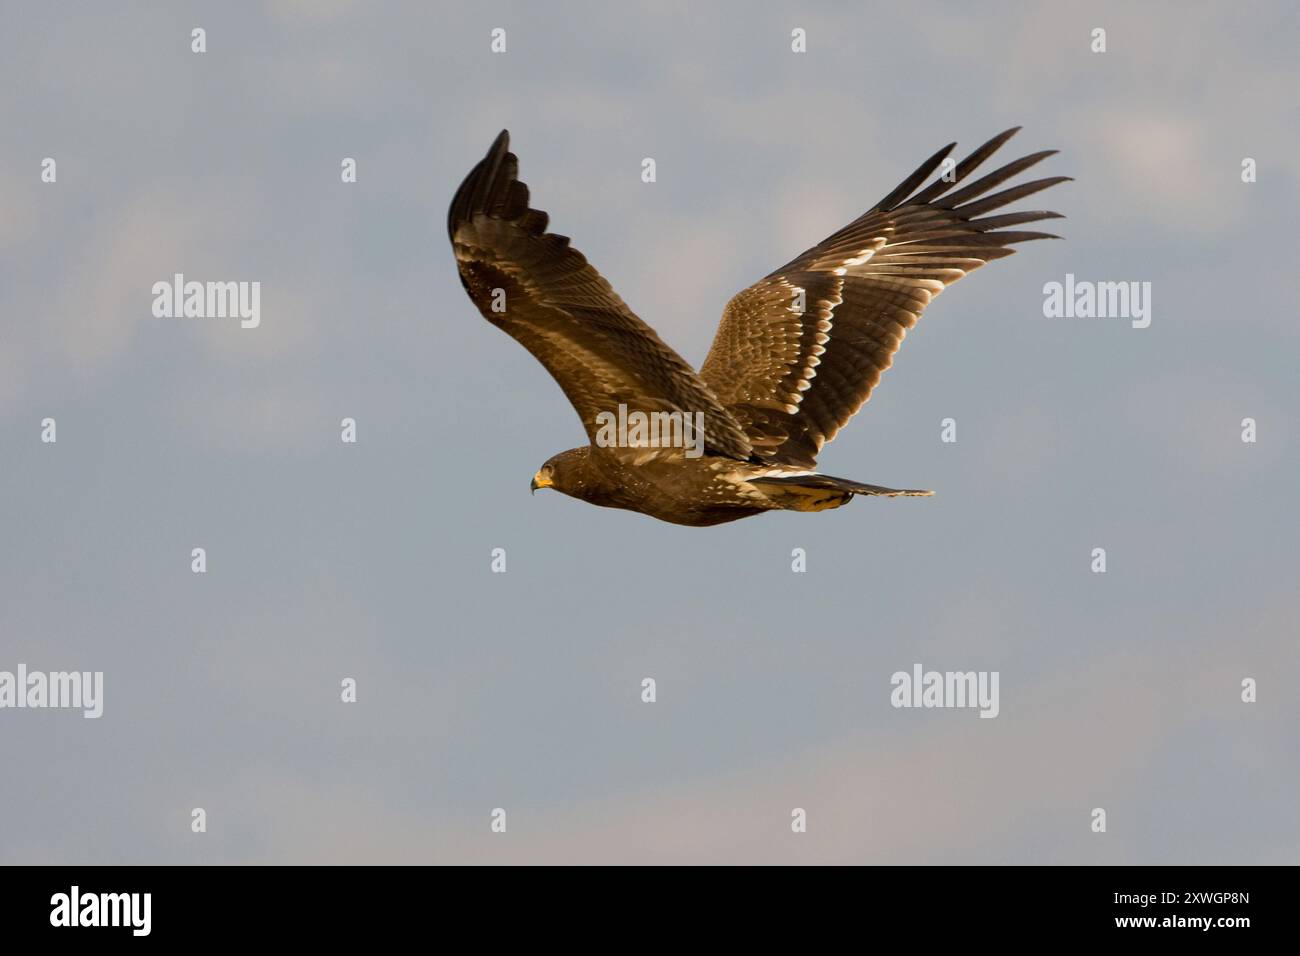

{"left": 699, "top": 129, "right": 1070, "bottom": 467}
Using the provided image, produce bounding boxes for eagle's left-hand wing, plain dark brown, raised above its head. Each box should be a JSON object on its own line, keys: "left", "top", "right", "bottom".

{"left": 447, "top": 130, "right": 753, "bottom": 459}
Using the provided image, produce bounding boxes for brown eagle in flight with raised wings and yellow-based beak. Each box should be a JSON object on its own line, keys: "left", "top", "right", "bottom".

{"left": 447, "top": 127, "right": 1070, "bottom": 527}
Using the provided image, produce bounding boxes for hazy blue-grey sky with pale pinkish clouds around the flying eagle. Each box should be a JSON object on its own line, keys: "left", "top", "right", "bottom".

{"left": 0, "top": 0, "right": 1300, "bottom": 865}
